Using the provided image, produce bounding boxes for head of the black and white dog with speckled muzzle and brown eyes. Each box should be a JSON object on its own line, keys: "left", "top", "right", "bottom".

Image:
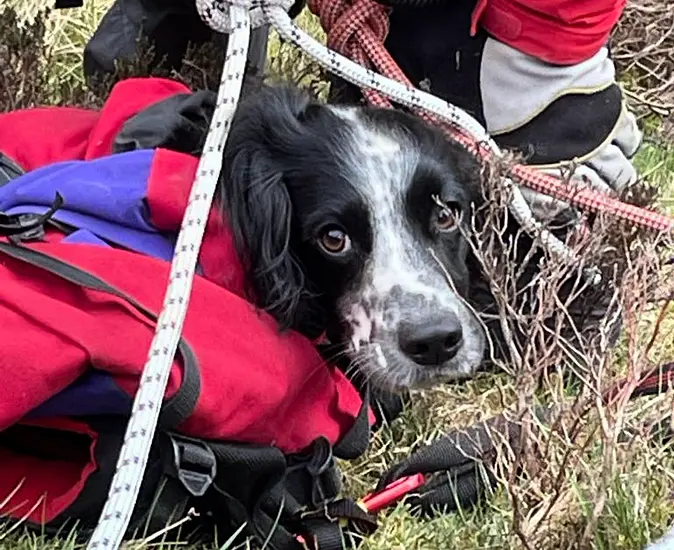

{"left": 220, "top": 88, "right": 485, "bottom": 389}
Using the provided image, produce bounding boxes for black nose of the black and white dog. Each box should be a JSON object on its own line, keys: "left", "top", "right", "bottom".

{"left": 398, "top": 313, "right": 463, "bottom": 366}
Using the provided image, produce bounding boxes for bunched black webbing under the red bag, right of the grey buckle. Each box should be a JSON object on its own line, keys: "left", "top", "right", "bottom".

{"left": 200, "top": 392, "right": 376, "bottom": 550}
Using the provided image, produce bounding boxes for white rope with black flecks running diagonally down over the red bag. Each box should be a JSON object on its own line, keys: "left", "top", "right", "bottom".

{"left": 82, "top": 4, "right": 251, "bottom": 550}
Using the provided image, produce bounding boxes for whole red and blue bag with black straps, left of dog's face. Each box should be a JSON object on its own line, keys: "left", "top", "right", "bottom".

{"left": 0, "top": 79, "right": 373, "bottom": 549}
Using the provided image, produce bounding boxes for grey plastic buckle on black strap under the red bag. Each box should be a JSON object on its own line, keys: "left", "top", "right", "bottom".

{"left": 169, "top": 434, "right": 217, "bottom": 497}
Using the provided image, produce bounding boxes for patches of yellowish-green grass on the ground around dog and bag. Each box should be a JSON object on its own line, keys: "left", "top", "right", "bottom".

{"left": 0, "top": 0, "right": 674, "bottom": 550}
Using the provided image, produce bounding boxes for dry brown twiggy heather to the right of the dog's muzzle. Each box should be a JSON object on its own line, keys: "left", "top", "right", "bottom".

{"left": 464, "top": 153, "right": 674, "bottom": 549}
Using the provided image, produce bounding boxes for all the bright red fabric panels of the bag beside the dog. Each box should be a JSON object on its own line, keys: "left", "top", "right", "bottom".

{"left": 0, "top": 79, "right": 374, "bottom": 521}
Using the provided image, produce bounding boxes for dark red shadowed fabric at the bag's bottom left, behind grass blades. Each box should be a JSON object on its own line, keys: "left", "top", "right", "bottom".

{"left": 0, "top": 418, "right": 97, "bottom": 524}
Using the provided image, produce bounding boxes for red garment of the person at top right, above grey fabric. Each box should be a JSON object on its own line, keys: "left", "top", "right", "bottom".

{"left": 471, "top": 0, "right": 626, "bottom": 65}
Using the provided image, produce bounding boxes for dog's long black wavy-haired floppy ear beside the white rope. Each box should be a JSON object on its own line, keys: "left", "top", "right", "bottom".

{"left": 219, "top": 87, "right": 320, "bottom": 330}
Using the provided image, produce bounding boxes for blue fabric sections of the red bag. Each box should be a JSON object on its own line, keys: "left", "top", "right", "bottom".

{"left": 0, "top": 150, "right": 186, "bottom": 418}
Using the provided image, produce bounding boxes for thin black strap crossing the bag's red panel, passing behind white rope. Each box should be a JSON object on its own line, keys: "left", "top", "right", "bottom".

{"left": 0, "top": 242, "right": 201, "bottom": 430}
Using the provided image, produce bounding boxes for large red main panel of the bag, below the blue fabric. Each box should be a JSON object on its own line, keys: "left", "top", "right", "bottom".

{"left": 0, "top": 243, "right": 361, "bottom": 452}
